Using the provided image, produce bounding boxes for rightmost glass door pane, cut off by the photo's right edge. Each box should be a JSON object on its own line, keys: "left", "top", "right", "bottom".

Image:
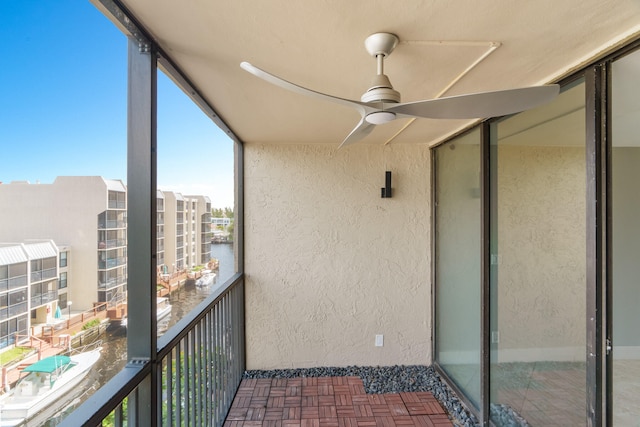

{"left": 611, "top": 52, "right": 640, "bottom": 426}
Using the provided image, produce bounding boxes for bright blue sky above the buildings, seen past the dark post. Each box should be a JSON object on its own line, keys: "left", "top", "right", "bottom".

{"left": 0, "top": 0, "right": 233, "bottom": 207}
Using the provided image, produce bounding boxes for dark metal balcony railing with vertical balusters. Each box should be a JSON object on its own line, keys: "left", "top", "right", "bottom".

{"left": 61, "top": 274, "right": 245, "bottom": 427}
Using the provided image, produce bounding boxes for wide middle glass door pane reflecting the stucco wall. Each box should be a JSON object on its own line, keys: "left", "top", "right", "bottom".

{"left": 490, "top": 83, "right": 586, "bottom": 426}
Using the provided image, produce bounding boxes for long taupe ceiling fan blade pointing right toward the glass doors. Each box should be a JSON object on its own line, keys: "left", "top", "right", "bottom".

{"left": 386, "top": 85, "right": 560, "bottom": 119}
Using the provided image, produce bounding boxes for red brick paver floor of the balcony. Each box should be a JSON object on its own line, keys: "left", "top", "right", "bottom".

{"left": 224, "top": 377, "right": 453, "bottom": 427}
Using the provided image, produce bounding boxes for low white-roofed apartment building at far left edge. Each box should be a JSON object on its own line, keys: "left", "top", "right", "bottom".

{"left": 0, "top": 240, "right": 58, "bottom": 349}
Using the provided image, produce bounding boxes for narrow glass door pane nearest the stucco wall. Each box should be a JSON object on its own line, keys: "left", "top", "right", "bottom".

{"left": 434, "top": 130, "right": 482, "bottom": 410}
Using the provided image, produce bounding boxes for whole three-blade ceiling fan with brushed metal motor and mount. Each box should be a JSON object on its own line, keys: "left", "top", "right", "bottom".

{"left": 240, "top": 33, "right": 560, "bottom": 147}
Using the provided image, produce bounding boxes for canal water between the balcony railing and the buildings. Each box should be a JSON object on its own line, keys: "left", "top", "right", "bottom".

{"left": 40, "top": 243, "right": 235, "bottom": 427}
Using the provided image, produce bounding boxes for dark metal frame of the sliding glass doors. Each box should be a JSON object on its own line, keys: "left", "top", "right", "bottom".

{"left": 431, "top": 40, "right": 640, "bottom": 427}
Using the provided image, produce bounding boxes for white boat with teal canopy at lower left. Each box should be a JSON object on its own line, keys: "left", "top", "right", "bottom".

{"left": 0, "top": 346, "right": 102, "bottom": 427}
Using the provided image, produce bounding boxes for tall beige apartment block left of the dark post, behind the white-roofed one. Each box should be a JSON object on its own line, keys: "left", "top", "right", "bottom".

{"left": 0, "top": 176, "right": 127, "bottom": 310}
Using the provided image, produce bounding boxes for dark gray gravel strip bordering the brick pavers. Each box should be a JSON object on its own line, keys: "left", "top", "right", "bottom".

{"left": 243, "top": 366, "right": 479, "bottom": 427}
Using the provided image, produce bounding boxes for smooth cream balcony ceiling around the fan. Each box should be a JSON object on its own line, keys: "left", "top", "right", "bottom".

{"left": 115, "top": 0, "right": 640, "bottom": 147}
